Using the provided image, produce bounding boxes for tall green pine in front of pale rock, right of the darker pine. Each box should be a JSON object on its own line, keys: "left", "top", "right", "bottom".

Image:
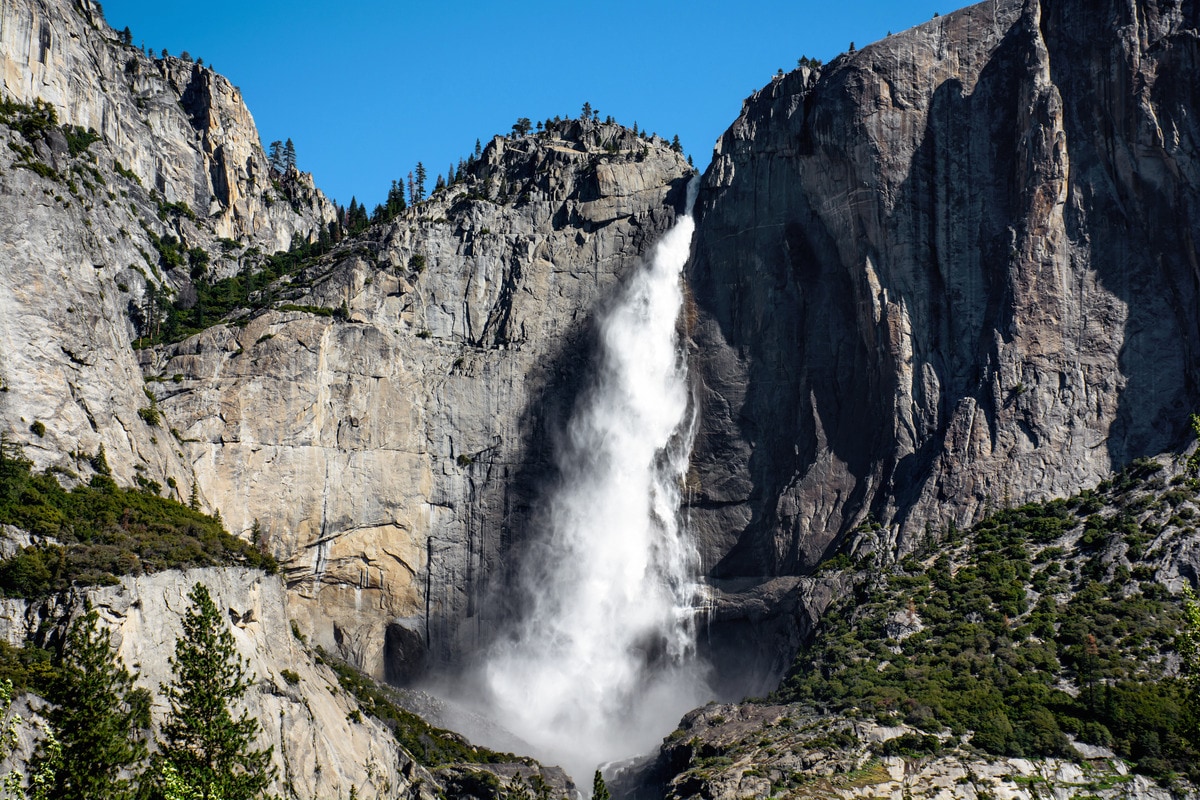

{"left": 160, "top": 583, "right": 275, "bottom": 800}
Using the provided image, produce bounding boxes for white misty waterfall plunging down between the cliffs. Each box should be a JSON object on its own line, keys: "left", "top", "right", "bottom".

{"left": 482, "top": 181, "right": 707, "bottom": 787}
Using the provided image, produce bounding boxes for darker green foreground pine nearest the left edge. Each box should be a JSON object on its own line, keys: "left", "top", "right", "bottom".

{"left": 40, "top": 603, "right": 150, "bottom": 800}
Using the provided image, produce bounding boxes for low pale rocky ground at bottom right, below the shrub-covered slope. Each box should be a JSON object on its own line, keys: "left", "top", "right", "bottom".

{"left": 612, "top": 705, "right": 1200, "bottom": 800}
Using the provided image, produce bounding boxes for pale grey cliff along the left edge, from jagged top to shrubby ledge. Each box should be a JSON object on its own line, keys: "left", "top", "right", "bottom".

{"left": 0, "top": 0, "right": 335, "bottom": 499}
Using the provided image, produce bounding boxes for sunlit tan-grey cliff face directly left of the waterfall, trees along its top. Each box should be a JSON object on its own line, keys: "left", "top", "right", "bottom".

{"left": 144, "top": 122, "right": 691, "bottom": 682}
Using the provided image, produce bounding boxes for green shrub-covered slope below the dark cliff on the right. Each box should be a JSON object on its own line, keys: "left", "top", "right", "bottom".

{"left": 776, "top": 459, "right": 1200, "bottom": 781}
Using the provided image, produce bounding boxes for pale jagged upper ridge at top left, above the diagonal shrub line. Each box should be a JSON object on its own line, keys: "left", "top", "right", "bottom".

{"left": 0, "top": 0, "right": 336, "bottom": 252}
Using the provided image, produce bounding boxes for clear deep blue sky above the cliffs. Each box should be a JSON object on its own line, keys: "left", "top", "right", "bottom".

{"left": 103, "top": 0, "right": 940, "bottom": 207}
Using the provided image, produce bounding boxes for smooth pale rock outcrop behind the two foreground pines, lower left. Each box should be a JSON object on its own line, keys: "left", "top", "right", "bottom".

{"left": 0, "top": 567, "right": 574, "bottom": 800}
